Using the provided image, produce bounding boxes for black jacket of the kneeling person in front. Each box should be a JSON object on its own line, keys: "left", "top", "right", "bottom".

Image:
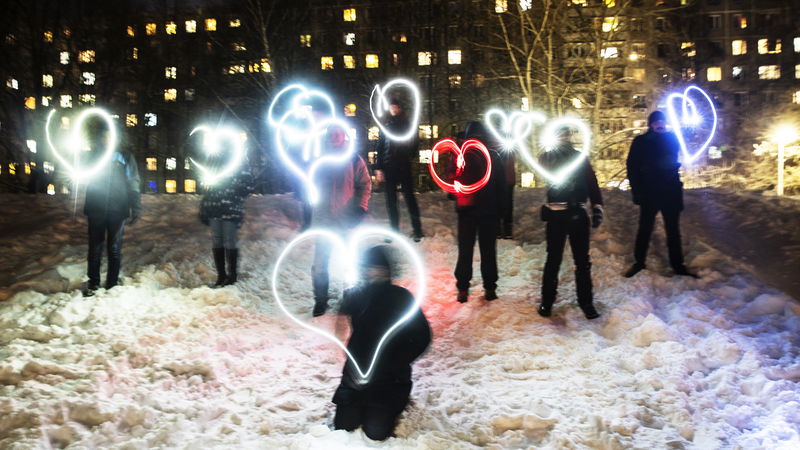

{"left": 334, "top": 281, "right": 431, "bottom": 394}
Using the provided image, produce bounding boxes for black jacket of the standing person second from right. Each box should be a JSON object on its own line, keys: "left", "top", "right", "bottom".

{"left": 539, "top": 143, "right": 603, "bottom": 205}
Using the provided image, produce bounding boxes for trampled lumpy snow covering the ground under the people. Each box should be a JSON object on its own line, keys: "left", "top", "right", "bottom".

{"left": 0, "top": 190, "right": 800, "bottom": 449}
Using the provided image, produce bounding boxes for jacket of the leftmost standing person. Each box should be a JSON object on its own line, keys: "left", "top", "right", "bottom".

{"left": 83, "top": 152, "right": 142, "bottom": 219}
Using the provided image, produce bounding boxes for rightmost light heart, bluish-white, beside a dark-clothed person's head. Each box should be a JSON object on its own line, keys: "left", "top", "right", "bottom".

{"left": 666, "top": 86, "right": 717, "bottom": 164}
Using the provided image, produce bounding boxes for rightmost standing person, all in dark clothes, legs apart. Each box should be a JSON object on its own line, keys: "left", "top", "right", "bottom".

{"left": 625, "top": 111, "right": 696, "bottom": 277}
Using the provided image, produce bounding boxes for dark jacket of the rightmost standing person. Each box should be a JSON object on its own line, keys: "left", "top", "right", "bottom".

{"left": 627, "top": 130, "right": 683, "bottom": 208}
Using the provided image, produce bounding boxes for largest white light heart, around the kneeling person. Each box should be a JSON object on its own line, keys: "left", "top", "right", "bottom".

{"left": 272, "top": 226, "right": 426, "bottom": 383}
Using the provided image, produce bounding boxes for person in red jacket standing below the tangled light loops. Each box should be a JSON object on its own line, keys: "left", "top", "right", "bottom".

{"left": 311, "top": 129, "right": 372, "bottom": 317}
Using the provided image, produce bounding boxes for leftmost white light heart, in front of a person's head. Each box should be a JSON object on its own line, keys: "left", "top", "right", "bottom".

{"left": 44, "top": 108, "right": 117, "bottom": 183}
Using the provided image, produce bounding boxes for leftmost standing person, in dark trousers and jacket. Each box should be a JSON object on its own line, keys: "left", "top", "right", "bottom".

{"left": 83, "top": 132, "right": 142, "bottom": 297}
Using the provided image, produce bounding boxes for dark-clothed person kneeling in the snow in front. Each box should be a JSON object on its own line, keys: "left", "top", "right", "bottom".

{"left": 333, "top": 246, "right": 431, "bottom": 441}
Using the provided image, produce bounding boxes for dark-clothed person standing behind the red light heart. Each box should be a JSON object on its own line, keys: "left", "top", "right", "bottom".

{"left": 451, "top": 121, "right": 506, "bottom": 303}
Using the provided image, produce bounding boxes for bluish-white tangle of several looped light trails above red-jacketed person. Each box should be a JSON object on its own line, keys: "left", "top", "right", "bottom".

{"left": 267, "top": 84, "right": 355, "bottom": 204}
